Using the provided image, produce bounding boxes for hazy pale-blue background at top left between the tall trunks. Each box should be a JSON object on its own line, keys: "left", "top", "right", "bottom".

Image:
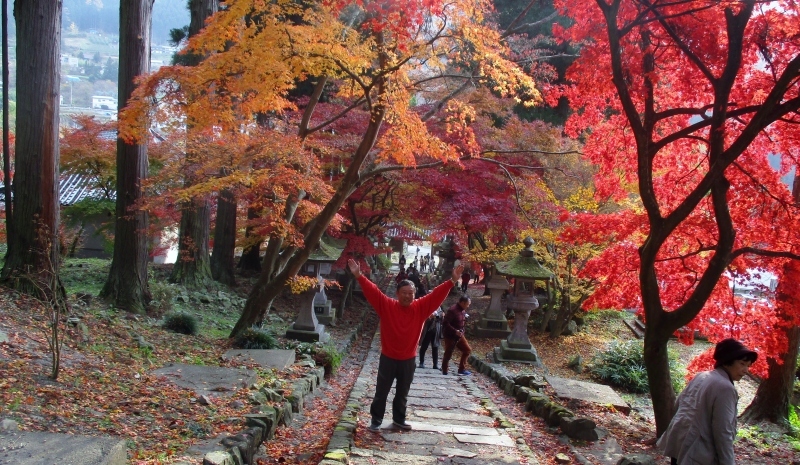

{"left": 63, "top": 0, "right": 189, "bottom": 44}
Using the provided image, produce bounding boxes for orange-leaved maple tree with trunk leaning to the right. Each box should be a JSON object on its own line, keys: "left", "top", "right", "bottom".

{"left": 122, "top": 0, "right": 539, "bottom": 335}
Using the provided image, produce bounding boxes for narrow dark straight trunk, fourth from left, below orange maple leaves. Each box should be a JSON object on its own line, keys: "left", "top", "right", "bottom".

{"left": 211, "top": 189, "right": 236, "bottom": 286}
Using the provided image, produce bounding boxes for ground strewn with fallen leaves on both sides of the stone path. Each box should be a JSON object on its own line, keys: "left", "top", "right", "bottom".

{"left": 0, "top": 260, "right": 800, "bottom": 465}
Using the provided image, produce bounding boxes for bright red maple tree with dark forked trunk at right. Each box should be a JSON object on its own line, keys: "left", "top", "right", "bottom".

{"left": 549, "top": 0, "right": 800, "bottom": 434}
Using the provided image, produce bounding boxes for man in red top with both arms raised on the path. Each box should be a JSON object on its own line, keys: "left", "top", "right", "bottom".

{"left": 347, "top": 259, "right": 464, "bottom": 431}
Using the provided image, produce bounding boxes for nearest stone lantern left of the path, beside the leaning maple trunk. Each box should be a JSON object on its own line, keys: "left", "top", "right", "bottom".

{"left": 286, "top": 238, "right": 344, "bottom": 342}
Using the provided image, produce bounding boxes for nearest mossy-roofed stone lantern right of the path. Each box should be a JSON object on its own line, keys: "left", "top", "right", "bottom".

{"left": 494, "top": 237, "right": 553, "bottom": 365}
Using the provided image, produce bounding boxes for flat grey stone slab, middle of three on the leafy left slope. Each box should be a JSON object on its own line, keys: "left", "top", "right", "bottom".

{"left": 152, "top": 363, "right": 257, "bottom": 397}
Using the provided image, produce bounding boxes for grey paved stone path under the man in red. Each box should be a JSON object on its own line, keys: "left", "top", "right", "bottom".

{"left": 321, "top": 332, "right": 538, "bottom": 465}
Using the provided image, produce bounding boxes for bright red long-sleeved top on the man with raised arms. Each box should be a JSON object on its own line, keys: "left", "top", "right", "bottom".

{"left": 358, "top": 275, "right": 453, "bottom": 360}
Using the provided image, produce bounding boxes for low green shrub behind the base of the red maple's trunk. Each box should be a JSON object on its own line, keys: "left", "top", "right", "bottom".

{"left": 590, "top": 340, "right": 683, "bottom": 393}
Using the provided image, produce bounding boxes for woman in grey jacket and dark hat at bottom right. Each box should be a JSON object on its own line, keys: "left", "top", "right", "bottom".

{"left": 658, "top": 339, "right": 758, "bottom": 465}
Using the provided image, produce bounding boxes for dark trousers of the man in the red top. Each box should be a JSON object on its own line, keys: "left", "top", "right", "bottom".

{"left": 369, "top": 354, "right": 417, "bottom": 424}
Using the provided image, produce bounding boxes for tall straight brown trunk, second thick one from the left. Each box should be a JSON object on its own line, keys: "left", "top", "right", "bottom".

{"left": 100, "top": 0, "right": 154, "bottom": 313}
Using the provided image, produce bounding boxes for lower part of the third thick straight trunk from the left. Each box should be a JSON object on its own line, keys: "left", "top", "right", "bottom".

{"left": 170, "top": 197, "right": 211, "bottom": 287}
